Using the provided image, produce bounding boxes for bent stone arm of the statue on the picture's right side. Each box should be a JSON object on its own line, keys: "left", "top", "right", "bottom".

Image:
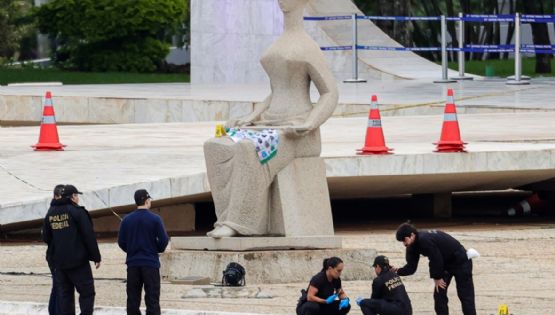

{"left": 305, "top": 54, "right": 339, "bottom": 130}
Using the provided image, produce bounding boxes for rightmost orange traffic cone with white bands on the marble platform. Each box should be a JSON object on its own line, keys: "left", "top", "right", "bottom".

{"left": 434, "top": 89, "right": 466, "bottom": 152}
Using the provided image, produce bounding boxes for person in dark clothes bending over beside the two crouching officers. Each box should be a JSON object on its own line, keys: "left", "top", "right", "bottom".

{"left": 393, "top": 223, "right": 476, "bottom": 315}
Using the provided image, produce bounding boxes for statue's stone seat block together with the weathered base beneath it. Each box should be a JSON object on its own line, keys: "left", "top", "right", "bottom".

{"left": 161, "top": 157, "right": 344, "bottom": 284}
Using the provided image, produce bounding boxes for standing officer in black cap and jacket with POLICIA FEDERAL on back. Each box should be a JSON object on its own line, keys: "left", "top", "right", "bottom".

{"left": 43, "top": 185, "right": 100, "bottom": 315}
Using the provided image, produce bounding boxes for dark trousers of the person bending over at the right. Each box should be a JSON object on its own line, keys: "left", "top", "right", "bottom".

{"left": 434, "top": 259, "right": 476, "bottom": 315}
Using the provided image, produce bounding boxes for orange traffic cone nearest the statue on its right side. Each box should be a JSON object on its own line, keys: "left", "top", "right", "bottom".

{"left": 357, "top": 95, "right": 393, "bottom": 155}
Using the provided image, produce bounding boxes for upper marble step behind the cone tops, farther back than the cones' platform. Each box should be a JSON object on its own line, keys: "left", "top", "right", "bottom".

{"left": 0, "top": 79, "right": 555, "bottom": 125}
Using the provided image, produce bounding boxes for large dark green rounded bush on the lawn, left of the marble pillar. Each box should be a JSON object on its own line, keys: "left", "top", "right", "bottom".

{"left": 36, "top": 0, "right": 188, "bottom": 72}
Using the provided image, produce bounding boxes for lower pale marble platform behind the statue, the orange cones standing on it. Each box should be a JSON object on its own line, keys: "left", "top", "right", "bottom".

{"left": 0, "top": 111, "right": 555, "bottom": 224}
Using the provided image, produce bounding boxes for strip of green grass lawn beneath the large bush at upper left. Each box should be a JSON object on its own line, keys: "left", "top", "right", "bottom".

{"left": 0, "top": 68, "right": 189, "bottom": 85}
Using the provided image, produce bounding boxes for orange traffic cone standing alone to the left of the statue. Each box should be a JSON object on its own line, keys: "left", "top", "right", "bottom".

{"left": 32, "top": 91, "right": 65, "bottom": 151}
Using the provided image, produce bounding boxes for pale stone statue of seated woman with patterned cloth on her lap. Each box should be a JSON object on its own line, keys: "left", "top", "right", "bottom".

{"left": 204, "top": 0, "right": 338, "bottom": 238}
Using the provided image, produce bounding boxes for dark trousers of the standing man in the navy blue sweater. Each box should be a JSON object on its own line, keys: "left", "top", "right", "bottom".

{"left": 127, "top": 267, "right": 160, "bottom": 315}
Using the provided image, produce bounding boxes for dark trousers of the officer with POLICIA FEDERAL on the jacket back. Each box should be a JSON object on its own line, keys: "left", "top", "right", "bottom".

{"left": 56, "top": 262, "right": 95, "bottom": 315}
